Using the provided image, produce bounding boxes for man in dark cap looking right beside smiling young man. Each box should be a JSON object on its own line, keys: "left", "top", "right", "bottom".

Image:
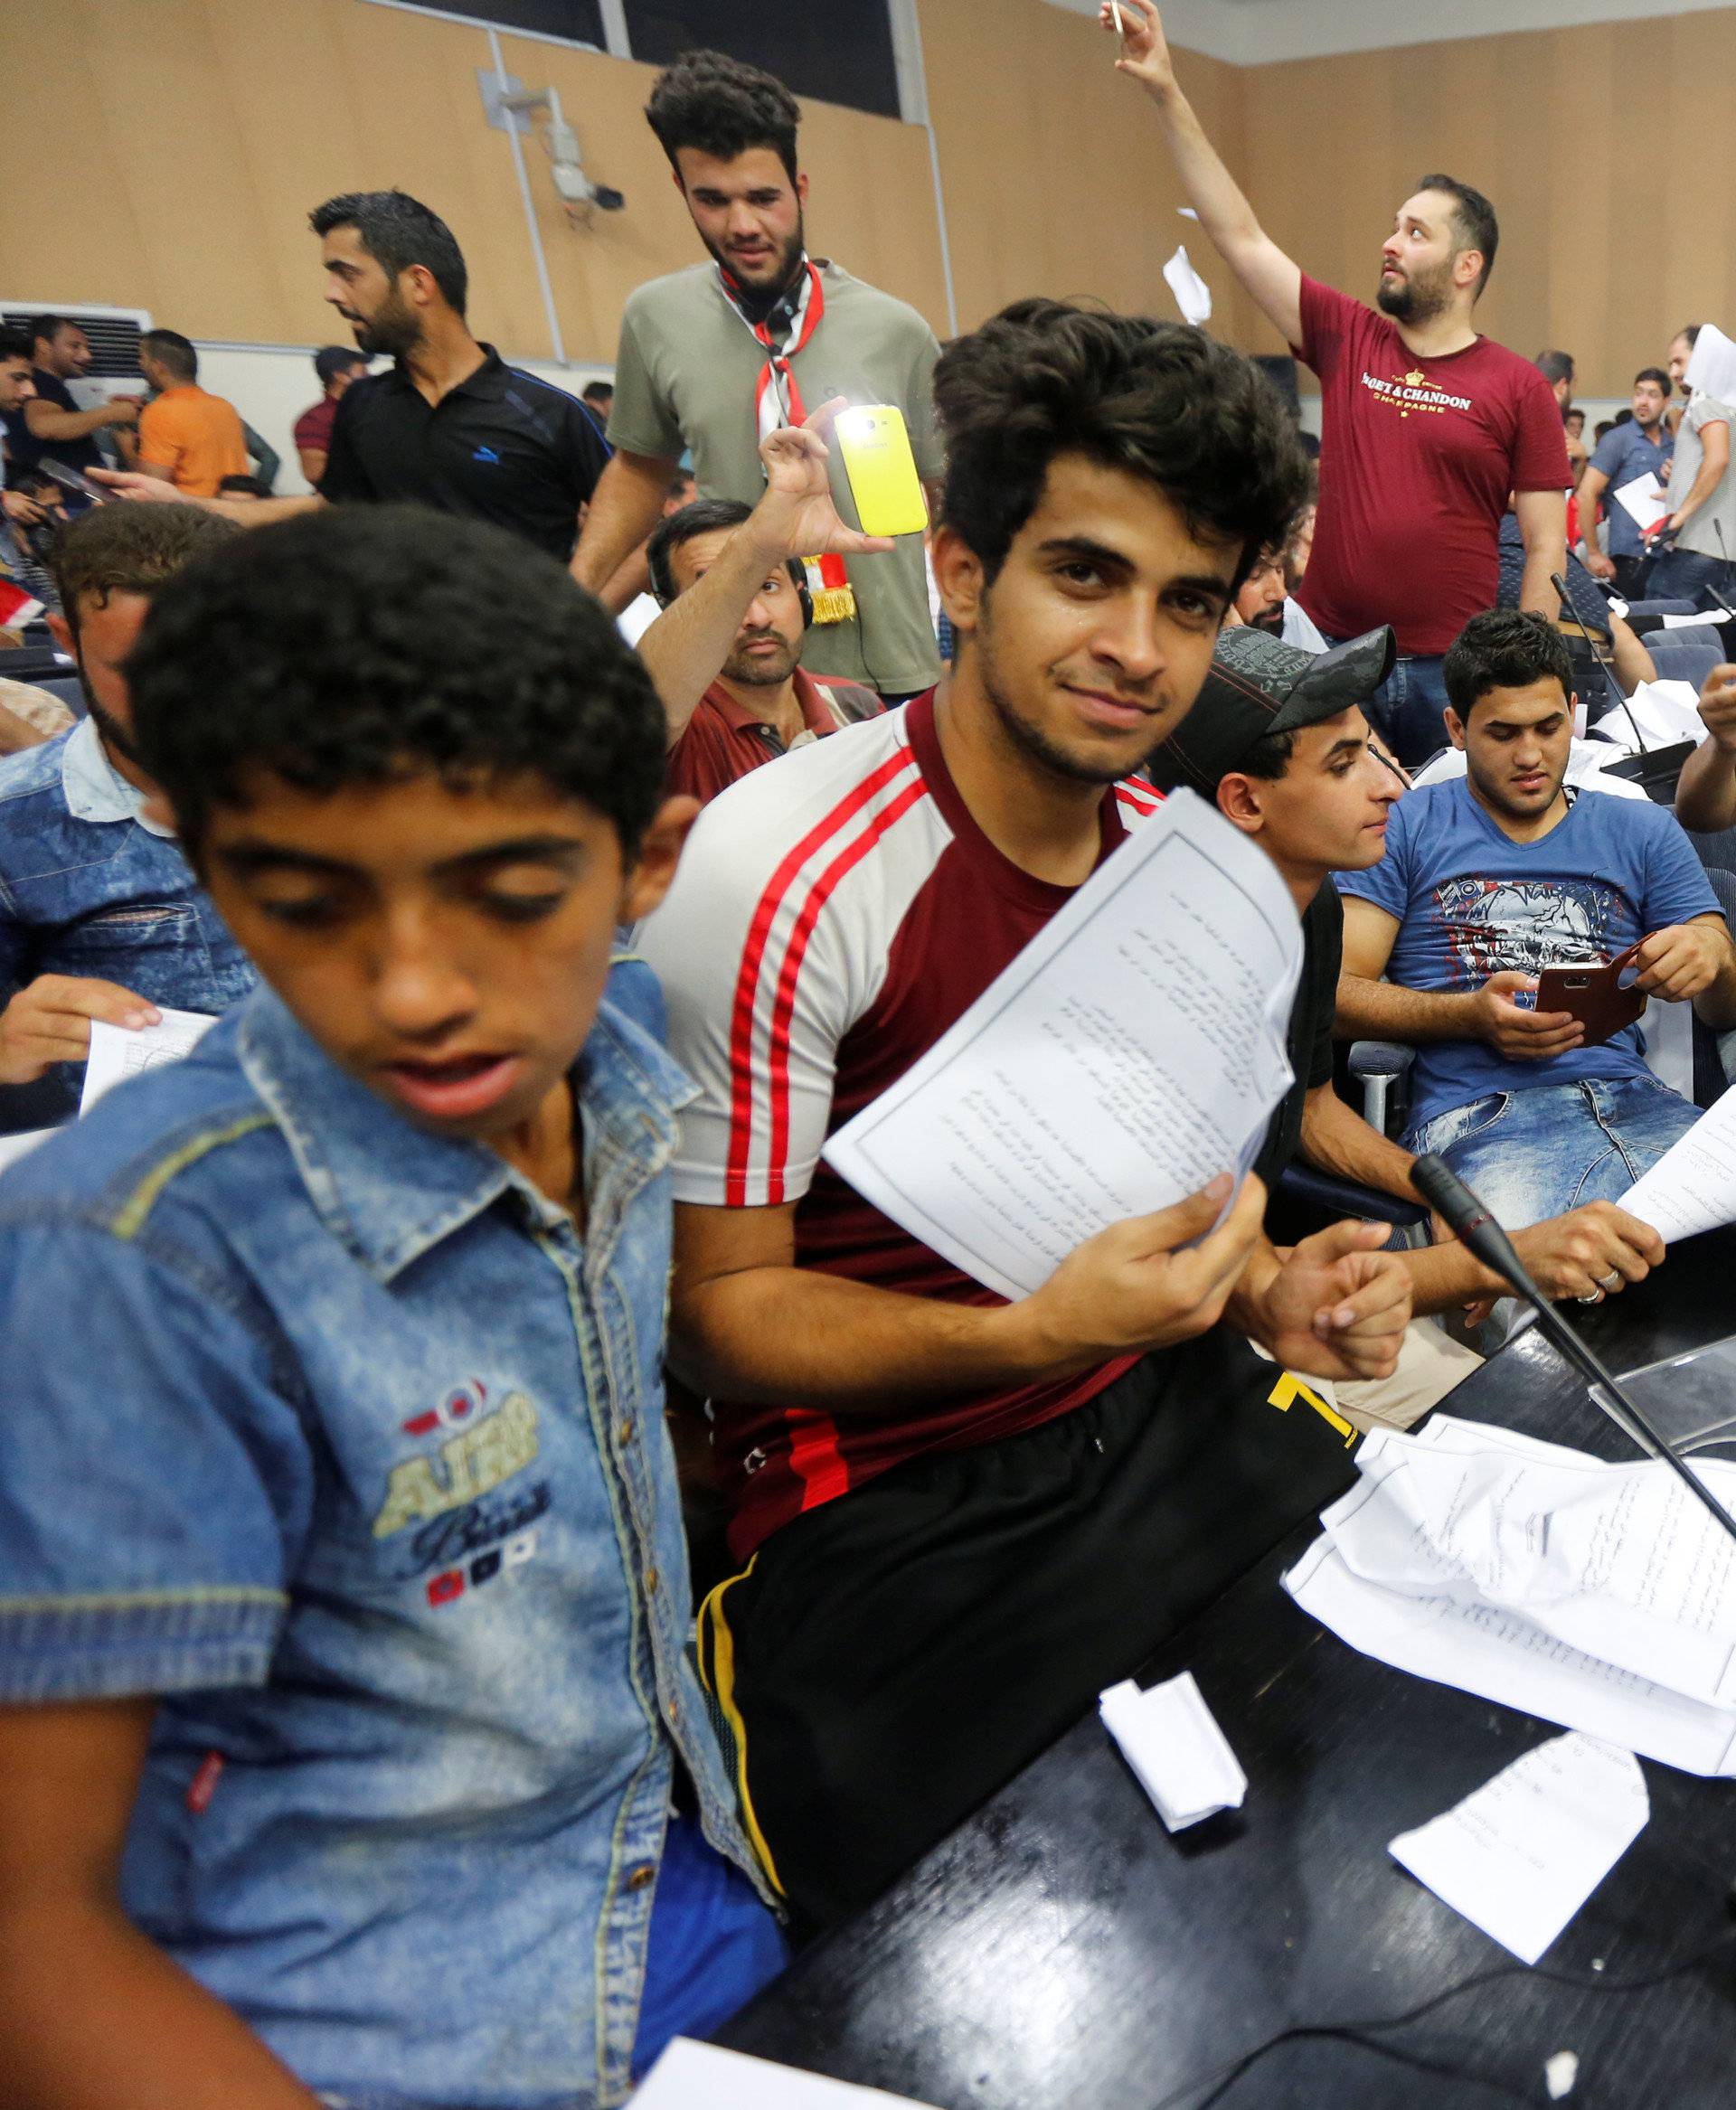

{"left": 1149, "top": 629, "right": 1662, "bottom": 1427}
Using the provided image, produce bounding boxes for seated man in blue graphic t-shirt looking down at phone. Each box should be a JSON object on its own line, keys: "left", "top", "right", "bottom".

{"left": 1337, "top": 610, "right": 1736, "bottom": 1232}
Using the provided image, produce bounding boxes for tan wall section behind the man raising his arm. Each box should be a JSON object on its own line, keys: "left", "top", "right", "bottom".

{"left": 1238, "top": 8, "right": 1736, "bottom": 397}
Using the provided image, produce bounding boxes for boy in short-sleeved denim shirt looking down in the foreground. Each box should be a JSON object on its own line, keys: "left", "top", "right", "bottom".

{"left": 0, "top": 508, "right": 783, "bottom": 2110}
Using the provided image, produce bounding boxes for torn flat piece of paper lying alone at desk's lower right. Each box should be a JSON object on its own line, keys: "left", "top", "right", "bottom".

{"left": 1388, "top": 1730, "right": 1652, "bottom": 1964}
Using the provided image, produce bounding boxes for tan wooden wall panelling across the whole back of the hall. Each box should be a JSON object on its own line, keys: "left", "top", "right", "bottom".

{"left": 0, "top": 0, "right": 1736, "bottom": 397}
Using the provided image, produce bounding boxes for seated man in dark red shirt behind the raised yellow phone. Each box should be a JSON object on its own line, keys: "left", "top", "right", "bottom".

{"left": 639, "top": 494, "right": 880, "bottom": 802}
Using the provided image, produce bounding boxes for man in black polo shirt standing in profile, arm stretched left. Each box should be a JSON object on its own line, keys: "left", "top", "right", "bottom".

{"left": 103, "top": 190, "right": 609, "bottom": 563}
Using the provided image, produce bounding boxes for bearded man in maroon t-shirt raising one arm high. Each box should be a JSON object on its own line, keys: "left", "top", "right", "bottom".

{"left": 1103, "top": 0, "right": 1573, "bottom": 764}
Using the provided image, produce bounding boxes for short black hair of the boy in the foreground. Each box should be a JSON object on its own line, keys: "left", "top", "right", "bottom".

{"left": 127, "top": 506, "right": 665, "bottom": 859}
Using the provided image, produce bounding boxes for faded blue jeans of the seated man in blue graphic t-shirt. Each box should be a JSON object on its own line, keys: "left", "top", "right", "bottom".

{"left": 1405, "top": 1076, "right": 1700, "bottom": 1230}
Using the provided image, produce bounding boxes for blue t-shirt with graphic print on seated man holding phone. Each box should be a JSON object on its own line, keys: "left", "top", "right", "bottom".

{"left": 1333, "top": 777, "right": 1717, "bottom": 1125}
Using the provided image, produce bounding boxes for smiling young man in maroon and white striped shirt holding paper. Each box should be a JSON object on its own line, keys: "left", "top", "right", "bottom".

{"left": 641, "top": 302, "right": 1409, "bottom": 1925}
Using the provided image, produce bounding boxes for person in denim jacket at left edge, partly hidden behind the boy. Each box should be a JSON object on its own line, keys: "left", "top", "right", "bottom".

{"left": 0, "top": 504, "right": 253, "bottom": 1131}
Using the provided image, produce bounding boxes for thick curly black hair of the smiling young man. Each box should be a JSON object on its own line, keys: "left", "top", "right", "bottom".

{"left": 934, "top": 299, "right": 1310, "bottom": 587}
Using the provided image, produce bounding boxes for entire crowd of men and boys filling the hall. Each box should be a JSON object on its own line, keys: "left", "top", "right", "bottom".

{"left": 0, "top": 0, "right": 1736, "bottom": 2110}
